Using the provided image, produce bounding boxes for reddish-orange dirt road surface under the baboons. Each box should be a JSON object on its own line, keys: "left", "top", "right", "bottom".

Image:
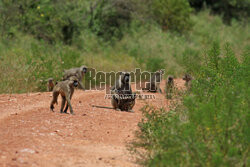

{"left": 0, "top": 79, "right": 184, "bottom": 167}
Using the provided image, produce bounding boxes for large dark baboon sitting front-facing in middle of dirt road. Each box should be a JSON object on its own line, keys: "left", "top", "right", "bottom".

{"left": 110, "top": 72, "right": 136, "bottom": 112}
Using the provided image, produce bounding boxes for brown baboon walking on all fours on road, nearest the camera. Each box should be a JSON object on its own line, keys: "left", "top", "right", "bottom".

{"left": 50, "top": 76, "right": 79, "bottom": 114}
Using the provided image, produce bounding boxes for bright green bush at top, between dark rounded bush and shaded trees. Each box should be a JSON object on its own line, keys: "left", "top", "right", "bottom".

{"left": 133, "top": 0, "right": 192, "bottom": 32}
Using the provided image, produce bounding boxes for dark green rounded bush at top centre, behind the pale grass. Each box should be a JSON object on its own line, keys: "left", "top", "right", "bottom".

{"left": 89, "top": 0, "right": 132, "bottom": 40}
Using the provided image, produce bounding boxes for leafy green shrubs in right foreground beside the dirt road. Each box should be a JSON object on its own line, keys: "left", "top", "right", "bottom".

{"left": 134, "top": 42, "right": 250, "bottom": 166}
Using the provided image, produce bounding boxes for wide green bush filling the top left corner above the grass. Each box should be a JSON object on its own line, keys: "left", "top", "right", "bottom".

{"left": 0, "top": 0, "right": 86, "bottom": 44}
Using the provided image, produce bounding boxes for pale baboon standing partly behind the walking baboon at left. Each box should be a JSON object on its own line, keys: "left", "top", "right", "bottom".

{"left": 62, "top": 65, "right": 88, "bottom": 90}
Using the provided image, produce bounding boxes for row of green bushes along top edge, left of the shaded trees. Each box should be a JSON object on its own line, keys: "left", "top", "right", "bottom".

{"left": 0, "top": 0, "right": 191, "bottom": 44}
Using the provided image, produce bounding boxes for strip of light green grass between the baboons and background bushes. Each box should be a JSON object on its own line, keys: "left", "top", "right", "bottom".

{"left": 0, "top": 11, "right": 250, "bottom": 93}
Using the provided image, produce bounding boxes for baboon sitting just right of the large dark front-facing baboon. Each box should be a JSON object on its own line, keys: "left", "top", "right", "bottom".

{"left": 142, "top": 70, "right": 164, "bottom": 93}
